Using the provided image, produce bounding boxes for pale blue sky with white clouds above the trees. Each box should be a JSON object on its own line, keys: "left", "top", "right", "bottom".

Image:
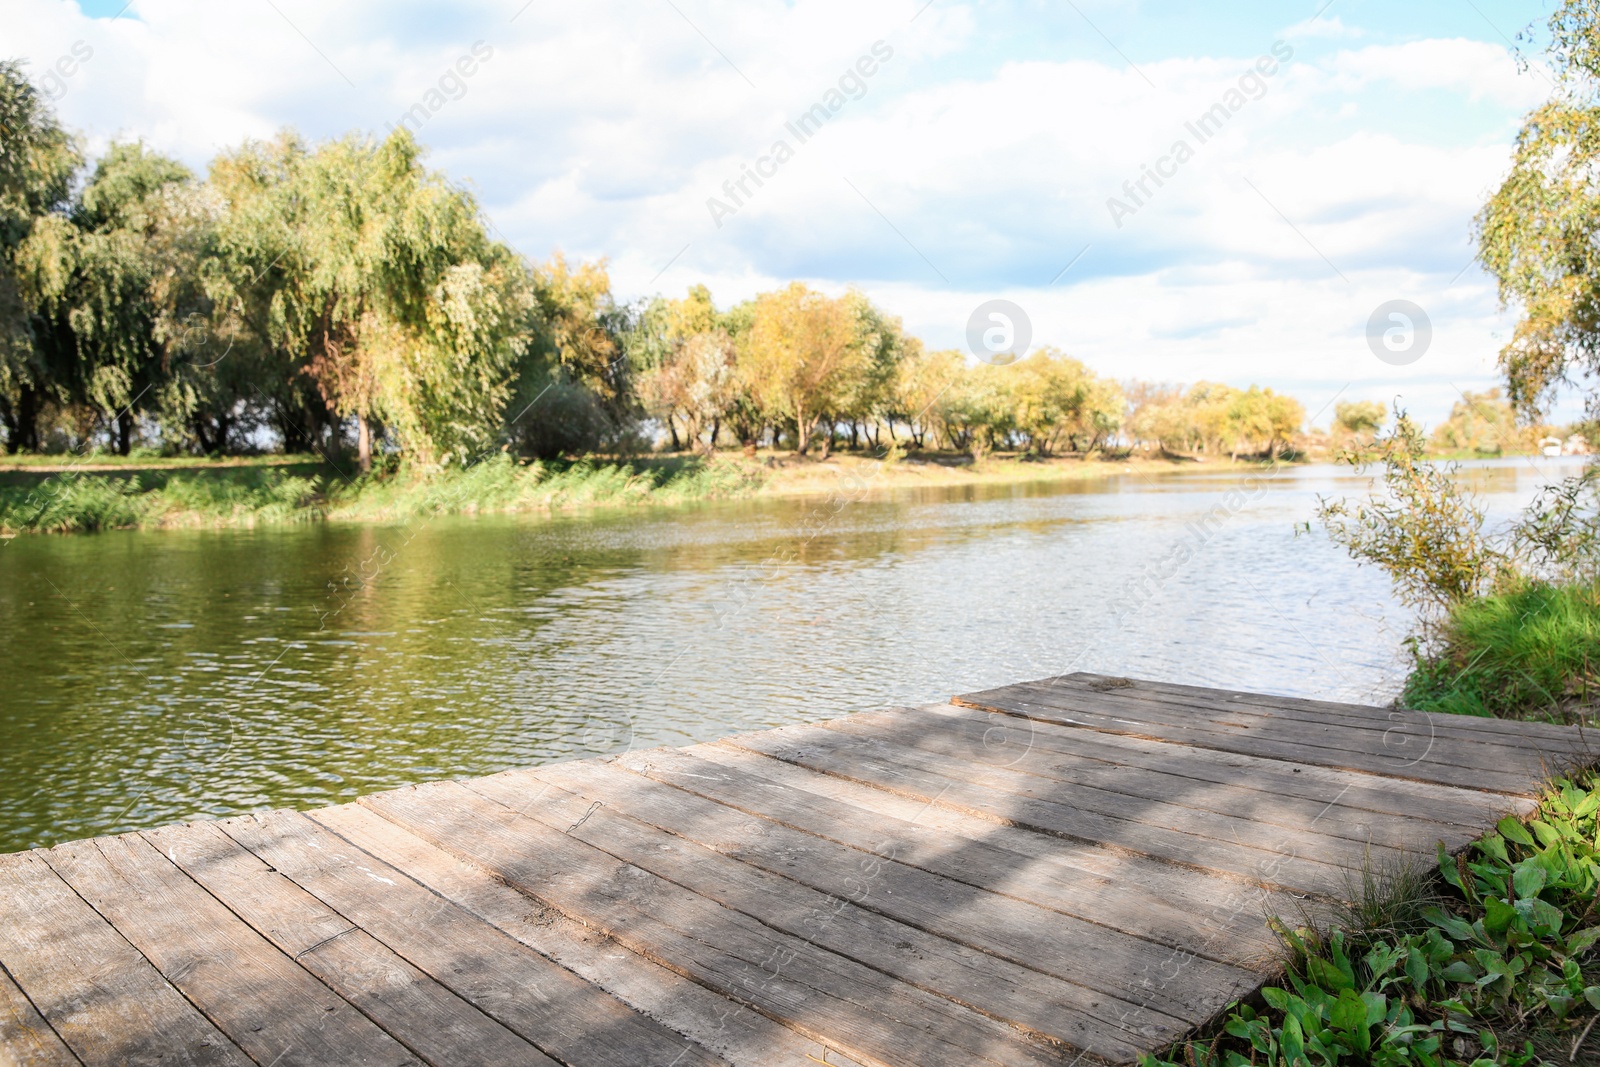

{"left": 0, "top": 0, "right": 1578, "bottom": 424}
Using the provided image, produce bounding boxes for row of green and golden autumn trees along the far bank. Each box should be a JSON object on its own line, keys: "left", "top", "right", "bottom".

{"left": 0, "top": 61, "right": 1304, "bottom": 470}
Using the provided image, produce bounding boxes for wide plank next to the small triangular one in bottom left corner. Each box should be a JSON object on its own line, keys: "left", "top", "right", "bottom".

{"left": 0, "top": 853, "right": 251, "bottom": 1067}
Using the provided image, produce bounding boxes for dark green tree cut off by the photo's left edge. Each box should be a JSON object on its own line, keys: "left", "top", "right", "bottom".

{"left": 0, "top": 61, "right": 83, "bottom": 453}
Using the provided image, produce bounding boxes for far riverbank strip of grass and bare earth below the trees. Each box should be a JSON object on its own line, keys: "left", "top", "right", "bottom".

{"left": 0, "top": 453, "right": 1261, "bottom": 536}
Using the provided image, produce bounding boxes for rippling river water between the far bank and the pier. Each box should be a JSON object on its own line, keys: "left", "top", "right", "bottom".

{"left": 0, "top": 461, "right": 1574, "bottom": 851}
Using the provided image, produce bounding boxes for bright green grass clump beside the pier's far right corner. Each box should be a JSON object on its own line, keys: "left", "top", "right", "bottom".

{"left": 1400, "top": 582, "right": 1600, "bottom": 721}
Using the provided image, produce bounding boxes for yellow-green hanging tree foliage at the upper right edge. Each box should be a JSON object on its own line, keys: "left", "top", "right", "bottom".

{"left": 1477, "top": 0, "right": 1600, "bottom": 418}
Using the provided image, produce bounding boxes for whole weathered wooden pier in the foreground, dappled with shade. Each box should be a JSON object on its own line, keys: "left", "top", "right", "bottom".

{"left": 0, "top": 675, "right": 1589, "bottom": 1067}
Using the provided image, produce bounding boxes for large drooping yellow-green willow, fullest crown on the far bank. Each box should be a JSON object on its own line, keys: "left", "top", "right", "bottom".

{"left": 213, "top": 130, "right": 531, "bottom": 470}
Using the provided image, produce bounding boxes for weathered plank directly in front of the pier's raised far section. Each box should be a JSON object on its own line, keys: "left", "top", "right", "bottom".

{"left": 914, "top": 704, "right": 1534, "bottom": 830}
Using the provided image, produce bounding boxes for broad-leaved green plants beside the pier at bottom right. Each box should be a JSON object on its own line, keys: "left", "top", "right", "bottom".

{"left": 1142, "top": 773, "right": 1600, "bottom": 1067}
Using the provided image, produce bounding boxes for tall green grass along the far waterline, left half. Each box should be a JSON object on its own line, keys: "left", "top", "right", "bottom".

{"left": 0, "top": 454, "right": 762, "bottom": 534}
